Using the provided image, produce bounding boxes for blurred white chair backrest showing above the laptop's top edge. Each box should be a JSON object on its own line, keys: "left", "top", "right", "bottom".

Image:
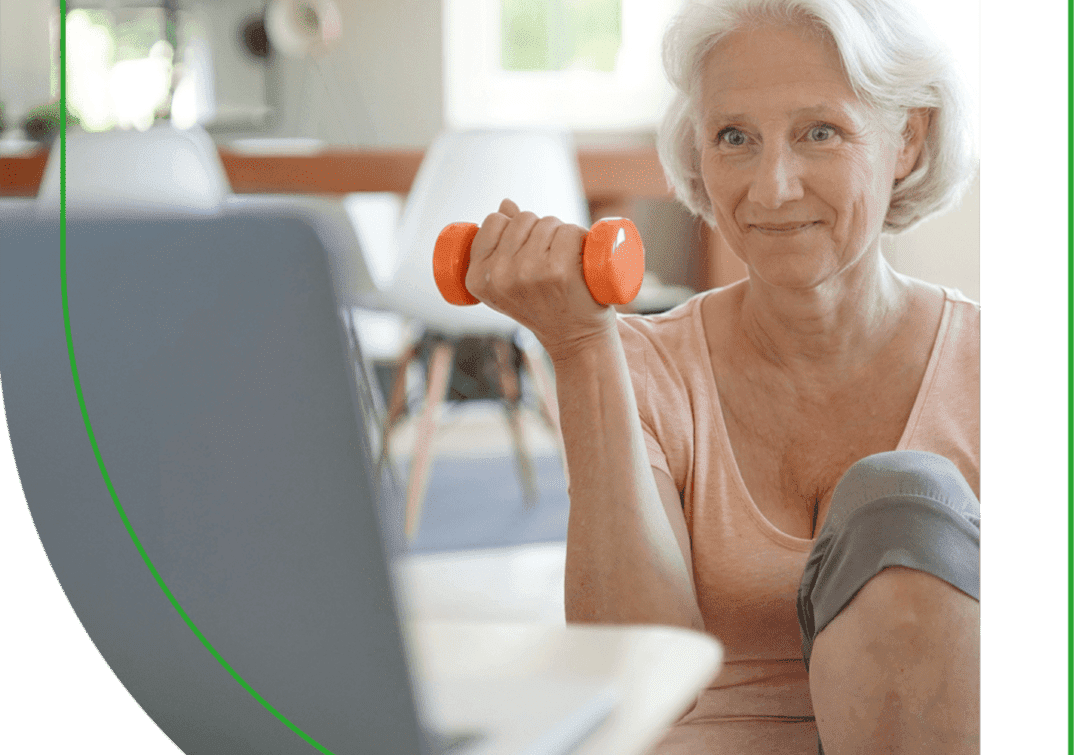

{"left": 38, "top": 124, "right": 231, "bottom": 217}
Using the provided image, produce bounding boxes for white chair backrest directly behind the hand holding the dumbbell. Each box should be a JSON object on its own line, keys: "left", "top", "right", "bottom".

{"left": 377, "top": 131, "right": 589, "bottom": 334}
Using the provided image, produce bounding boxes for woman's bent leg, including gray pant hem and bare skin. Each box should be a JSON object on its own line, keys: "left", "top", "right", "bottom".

{"left": 798, "top": 452, "right": 981, "bottom": 755}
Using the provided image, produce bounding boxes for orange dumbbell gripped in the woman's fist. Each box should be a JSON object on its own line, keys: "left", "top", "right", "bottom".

{"left": 434, "top": 218, "right": 644, "bottom": 305}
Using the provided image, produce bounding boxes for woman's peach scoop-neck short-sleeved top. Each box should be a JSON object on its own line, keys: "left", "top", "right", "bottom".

{"left": 619, "top": 289, "right": 981, "bottom": 755}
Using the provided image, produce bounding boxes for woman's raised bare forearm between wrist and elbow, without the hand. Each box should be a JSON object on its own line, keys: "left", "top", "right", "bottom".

{"left": 551, "top": 328, "right": 705, "bottom": 631}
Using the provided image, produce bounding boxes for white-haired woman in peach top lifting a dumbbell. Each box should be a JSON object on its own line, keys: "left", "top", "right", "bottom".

{"left": 466, "top": 0, "right": 981, "bottom": 755}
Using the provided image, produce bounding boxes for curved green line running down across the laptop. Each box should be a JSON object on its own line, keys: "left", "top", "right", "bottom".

{"left": 59, "top": 0, "right": 333, "bottom": 755}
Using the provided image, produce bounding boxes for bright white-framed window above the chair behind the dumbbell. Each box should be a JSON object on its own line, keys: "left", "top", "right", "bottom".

{"left": 442, "top": 0, "right": 680, "bottom": 131}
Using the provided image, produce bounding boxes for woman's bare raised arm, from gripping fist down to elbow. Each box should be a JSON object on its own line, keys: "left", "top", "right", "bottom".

{"left": 465, "top": 200, "right": 704, "bottom": 629}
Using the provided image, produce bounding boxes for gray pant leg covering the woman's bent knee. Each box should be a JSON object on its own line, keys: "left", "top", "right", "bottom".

{"left": 797, "top": 451, "right": 982, "bottom": 669}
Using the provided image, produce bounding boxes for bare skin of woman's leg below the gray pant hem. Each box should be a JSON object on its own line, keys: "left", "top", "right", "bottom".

{"left": 809, "top": 566, "right": 981, "bottom": 755}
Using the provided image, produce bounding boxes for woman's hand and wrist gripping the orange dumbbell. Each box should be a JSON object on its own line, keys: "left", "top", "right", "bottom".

{"left": 465, "top": 200, "right": 616, "bottom": 361}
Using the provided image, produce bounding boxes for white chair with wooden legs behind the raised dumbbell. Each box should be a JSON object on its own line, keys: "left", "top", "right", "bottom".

{"left": 365, "top": 131, "right": 589, "bottom": 543}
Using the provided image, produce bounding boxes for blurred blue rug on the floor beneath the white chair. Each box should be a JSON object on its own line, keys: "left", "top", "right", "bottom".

{"left": 382, "top": 456, "right": 570, "bottom": 554}
